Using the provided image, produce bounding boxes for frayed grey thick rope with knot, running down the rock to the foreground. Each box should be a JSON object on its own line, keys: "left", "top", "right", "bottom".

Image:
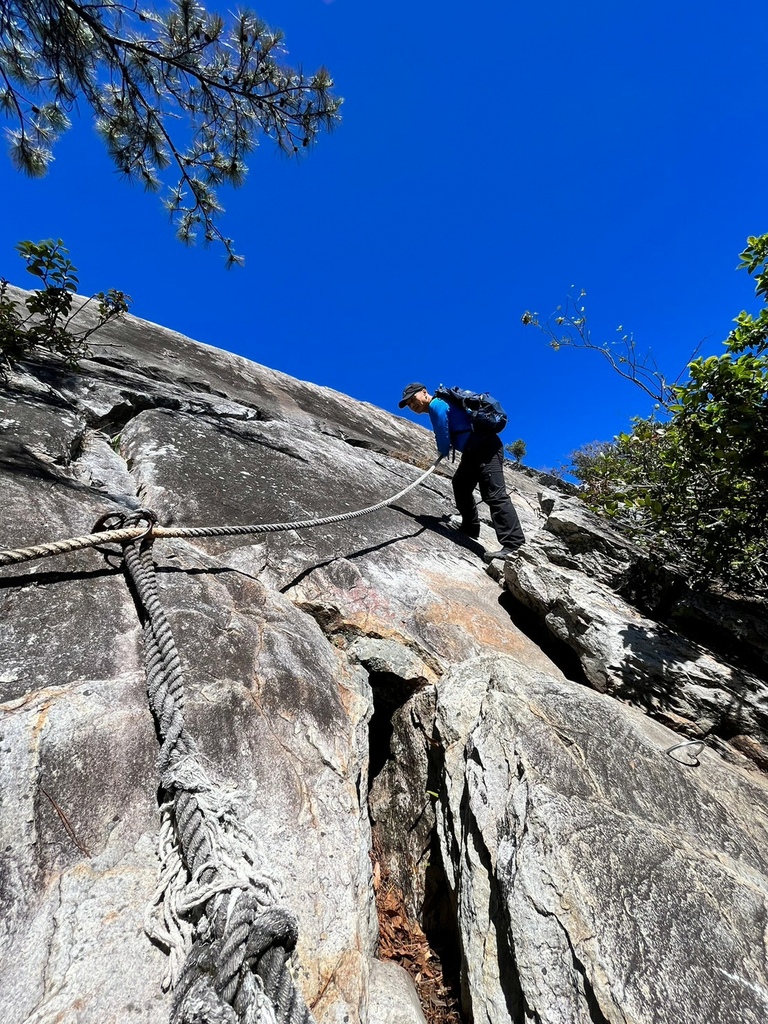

{"left": 124, "top": 513, "right": 311, "bottom": 1024}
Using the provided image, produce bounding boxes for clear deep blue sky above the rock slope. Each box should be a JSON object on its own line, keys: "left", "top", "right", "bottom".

{"left": 0, "top": 0, "right": 768, "bottom": 468}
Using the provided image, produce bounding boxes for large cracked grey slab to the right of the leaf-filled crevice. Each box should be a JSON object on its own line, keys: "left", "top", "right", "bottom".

{"left": 436, "top": 657, "right": 768, "bottom": 1024}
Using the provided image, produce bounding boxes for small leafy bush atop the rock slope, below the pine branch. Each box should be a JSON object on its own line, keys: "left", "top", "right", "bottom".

{"left": 0, "top": 239, "right": 131, "bottom": 367}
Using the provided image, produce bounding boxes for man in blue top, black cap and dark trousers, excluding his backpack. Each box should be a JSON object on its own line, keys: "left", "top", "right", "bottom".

{"left": 399, "top": 384, "right": 525, "bottom": 562}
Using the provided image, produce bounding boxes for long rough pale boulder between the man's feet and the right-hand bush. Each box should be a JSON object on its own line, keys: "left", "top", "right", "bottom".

{"left": 505, "top": 520, "right": 768, "bottom": 766}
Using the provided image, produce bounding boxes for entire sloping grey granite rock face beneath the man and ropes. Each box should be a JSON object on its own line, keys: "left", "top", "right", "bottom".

{"left": 0, "top": 296, "right": 768, "bottom": 1024}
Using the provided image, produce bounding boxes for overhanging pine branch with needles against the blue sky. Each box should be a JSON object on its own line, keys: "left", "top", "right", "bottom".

{"left": 0, "top": 0, "right": 341, "bottom": 256}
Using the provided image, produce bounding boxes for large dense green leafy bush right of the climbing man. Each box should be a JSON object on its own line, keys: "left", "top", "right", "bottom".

{"left": 571, "top": 234, "right": 768, "bottom": 594}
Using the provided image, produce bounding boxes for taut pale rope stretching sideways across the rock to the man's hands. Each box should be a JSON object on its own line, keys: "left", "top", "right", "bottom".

{"left": 0, "top": 456, "right": 442, "bottom": 567}
